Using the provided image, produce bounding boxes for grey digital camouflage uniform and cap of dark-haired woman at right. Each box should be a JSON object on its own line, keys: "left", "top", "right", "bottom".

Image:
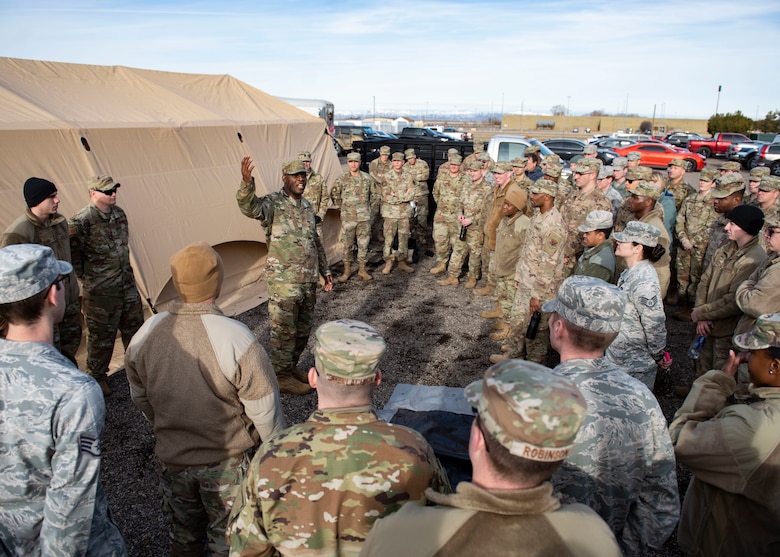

{"left": 605, "top": 221, "right": 666, "bottom": 391}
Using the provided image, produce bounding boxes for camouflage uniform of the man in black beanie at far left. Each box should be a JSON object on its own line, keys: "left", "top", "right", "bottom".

{"left": 0, "top": 209, "right": 81, "bottom": 365}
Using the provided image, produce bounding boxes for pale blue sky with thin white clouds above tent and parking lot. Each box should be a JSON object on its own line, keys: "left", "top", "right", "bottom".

{"left": 0, "top": 0, "right": 780, "bottom": 118}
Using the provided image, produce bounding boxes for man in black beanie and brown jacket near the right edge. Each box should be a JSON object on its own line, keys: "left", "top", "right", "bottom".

{"left": 688, "top": 205, "right": 767, "bottom": 386}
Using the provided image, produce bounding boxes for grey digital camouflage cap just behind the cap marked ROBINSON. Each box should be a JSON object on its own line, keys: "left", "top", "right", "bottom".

{"left": 542, "top": 275, "right": 626, "bottom": 333}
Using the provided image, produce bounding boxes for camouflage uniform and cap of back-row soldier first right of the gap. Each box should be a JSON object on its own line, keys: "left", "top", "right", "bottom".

{"left": 433, "top": 156, "right": 471, "bottom": 272}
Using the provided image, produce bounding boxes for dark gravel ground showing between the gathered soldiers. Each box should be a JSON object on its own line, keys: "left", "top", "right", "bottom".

{"left": 102, "top": 232, "right": 693, "bottom": 557}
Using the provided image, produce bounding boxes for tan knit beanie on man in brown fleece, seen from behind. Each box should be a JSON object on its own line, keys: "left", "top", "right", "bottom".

{"left": 171, "top": 242, "right": 225, "bottom": 303}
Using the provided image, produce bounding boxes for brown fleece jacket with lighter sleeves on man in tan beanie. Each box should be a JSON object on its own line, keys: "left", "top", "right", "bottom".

{"left": 125, "top": 302, "right": 286, "bottom": 468}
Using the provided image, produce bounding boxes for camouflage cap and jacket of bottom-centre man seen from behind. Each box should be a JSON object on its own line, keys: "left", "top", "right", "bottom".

{"left": 228, "top": 320, "right": 450, "bottom": 557}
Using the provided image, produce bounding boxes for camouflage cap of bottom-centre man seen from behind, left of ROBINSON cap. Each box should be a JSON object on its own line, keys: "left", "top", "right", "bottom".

{"left": 313, "top": 319, "right": 387, "bottom": 385}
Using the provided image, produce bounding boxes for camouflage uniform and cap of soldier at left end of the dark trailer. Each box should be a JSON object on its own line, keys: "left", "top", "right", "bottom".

{"left": 330, "top": 153, "right": 379, "bottom": 263}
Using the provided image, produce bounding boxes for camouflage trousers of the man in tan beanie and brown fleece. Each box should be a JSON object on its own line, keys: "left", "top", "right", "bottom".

{"left": 155, "top": 453, "right": 250, "bottom": 557}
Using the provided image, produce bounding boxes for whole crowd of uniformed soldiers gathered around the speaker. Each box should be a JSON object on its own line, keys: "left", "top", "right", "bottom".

{"left": 0, "top": 137, "right": 780, "bottom": 556}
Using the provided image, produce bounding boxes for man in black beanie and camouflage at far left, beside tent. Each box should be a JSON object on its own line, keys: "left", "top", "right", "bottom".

{"left": 0, "top": 177, "right": 81, "bottom": 365}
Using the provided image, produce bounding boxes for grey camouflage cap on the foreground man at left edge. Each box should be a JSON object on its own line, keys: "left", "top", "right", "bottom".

{"left": 0, "top": 244, "right": 73, "bottom": 304}
